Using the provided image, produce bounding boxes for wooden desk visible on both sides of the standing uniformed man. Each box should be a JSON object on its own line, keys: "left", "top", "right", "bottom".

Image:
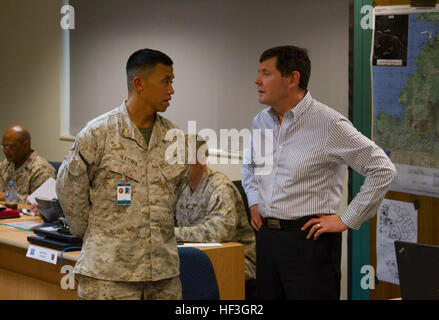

{"left": 0, "top": 216, "right": 245, "bottom": 300}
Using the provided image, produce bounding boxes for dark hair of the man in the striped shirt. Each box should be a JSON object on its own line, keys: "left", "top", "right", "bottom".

{"left": 259, "top": 46, "right": 311, "bottom": 90}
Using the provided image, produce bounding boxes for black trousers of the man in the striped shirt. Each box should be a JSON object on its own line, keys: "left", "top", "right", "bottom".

{"left": 256, "top": 217, "right": 341, "bottom": 300}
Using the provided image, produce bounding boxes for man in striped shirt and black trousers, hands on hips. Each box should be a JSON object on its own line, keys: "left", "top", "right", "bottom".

{"left": 242, "top": 46, "right": 396, "bottom": 299}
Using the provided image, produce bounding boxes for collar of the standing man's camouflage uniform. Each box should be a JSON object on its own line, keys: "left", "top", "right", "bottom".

{"left": 119, "top": 101, "right": 167, "bottom": 150}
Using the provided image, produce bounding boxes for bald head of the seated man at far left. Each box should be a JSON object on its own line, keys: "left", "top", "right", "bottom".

{"left": 2, "top": 125, "right": 32, "bottom": 168}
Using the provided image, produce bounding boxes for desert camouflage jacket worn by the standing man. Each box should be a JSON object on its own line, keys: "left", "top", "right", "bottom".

{"left": 56, "top": 103, "right": 188, "bottom": 281}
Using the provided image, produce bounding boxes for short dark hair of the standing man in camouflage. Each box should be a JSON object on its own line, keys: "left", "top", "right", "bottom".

{"left": 126, "top": 49, "right": 174, "bottom": 91}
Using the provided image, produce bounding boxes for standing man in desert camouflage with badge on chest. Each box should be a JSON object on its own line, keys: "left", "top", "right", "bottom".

{"left": 57, "top": 49, "right": 188, "bottom": 299}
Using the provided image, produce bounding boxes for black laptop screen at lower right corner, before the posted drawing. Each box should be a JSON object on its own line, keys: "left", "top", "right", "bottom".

{"left": 395, "top": 240, "right": 439, "bottom": 300}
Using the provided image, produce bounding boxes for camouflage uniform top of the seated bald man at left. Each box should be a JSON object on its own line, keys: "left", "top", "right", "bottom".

{"left": 0, "top": 151, "right": 56, "bottom": 203}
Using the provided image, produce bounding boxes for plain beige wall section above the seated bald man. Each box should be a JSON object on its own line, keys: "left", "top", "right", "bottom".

{"left": 0, "top": 0, "right": 72, "bottom": 161}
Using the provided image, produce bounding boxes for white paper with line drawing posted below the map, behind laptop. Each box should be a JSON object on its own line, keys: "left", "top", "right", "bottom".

{"left": 376, "top": 199, "right": 418, "bottom": 285}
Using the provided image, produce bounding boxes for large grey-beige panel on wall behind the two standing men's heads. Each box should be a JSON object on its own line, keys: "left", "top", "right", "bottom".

{"left": 70, "top": 0, "right": 349, "bottom": 151}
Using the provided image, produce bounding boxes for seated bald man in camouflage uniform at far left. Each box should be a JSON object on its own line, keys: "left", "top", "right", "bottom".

{"left": 0, "top": 126, "right": 56, "bottom": 203}
